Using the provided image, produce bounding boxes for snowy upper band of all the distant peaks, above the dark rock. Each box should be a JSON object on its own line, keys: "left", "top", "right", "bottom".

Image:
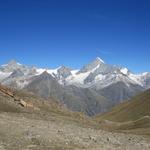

{"left": 0, "top": 57, "right": 150, "bottom": 89}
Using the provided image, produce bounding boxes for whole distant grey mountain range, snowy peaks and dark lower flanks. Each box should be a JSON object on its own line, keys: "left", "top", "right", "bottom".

{"left": 0, "top": 57, "right": 150, "bottom": 116}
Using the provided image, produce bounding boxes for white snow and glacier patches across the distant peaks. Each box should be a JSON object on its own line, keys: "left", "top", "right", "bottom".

{"left": 0, "top": 57, "right": 150, "bottom": 87}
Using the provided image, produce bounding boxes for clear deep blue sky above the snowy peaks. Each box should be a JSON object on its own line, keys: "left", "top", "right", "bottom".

{"left": 0, "top": 0, "right": 150, "bottom": 72}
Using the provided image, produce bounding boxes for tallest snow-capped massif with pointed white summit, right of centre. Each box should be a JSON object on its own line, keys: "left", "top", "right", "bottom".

{"left": 61, "top": 58, "right": 150, "bottom": 89}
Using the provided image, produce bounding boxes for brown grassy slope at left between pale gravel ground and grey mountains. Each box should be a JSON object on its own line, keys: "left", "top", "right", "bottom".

{"left": 0, "top": 86, "right": 96, "bottom": 127}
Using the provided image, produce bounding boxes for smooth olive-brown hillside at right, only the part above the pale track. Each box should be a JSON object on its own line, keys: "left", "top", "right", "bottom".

{"left": 97, "top": 90, "right": 150, "bottom": 122}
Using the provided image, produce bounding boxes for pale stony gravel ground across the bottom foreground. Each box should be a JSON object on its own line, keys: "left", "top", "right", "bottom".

{"left": 0, "top": 113, "right": 150, "bottom": 150}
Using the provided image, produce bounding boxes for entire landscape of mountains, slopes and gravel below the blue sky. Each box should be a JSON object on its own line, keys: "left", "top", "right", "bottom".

{"left": 0, "top": 58, "right": 150, "bottom": 150}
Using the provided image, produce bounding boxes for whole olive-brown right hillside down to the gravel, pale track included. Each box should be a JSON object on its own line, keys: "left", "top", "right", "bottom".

{"left": 95, "top": 90, "right": 150, "bottom": 135}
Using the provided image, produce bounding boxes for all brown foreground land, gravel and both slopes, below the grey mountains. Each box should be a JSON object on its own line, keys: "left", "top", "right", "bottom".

{"left": 0, "top": 80, "right": 150, "bottom": 150}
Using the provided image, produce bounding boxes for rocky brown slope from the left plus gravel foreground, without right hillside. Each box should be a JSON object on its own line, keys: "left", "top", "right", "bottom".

{"left": 0, "top": 86, "right": 150, "bottom": 150}
